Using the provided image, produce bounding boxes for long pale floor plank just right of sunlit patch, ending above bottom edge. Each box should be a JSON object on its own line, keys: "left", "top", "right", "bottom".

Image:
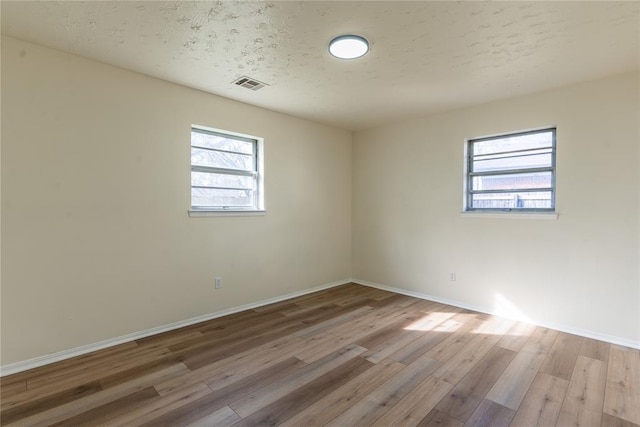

{"left": 487, "top": 328, "right": 558, "bottom": 410}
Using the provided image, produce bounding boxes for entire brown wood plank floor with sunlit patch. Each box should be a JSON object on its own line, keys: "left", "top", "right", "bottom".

{"left": 0, "top": 284, "right": 640, "bottom": 427}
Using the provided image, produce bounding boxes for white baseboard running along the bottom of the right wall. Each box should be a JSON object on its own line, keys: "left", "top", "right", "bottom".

{"left": 351, "top": 279, "right": 640, "bottom": 350}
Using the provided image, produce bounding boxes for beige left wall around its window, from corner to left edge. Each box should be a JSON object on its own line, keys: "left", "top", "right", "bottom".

{"left": 1, "top": 37, "right": 351, "bottom": 365}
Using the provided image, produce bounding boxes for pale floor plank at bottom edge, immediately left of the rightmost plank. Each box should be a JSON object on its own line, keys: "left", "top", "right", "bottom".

{"left": 558, "top": 356, "right": 607, "bottom": 426}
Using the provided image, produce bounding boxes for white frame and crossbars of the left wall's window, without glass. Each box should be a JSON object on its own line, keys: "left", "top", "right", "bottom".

{"left": 189, "top": 125, "right": 266, "bottom": 217}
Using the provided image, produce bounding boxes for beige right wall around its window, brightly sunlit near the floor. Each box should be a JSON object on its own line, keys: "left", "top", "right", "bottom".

{"left": 352, "top": 74, "right": 640, "bottom": 346}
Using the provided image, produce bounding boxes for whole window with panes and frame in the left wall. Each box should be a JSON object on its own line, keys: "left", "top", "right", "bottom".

{"left": 191, "top": 126, "right": 264, "bottom": 212}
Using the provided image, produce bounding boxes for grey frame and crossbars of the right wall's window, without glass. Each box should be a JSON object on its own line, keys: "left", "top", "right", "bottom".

{"left": 462, "top": 126, "right": 557, "bottom": 214}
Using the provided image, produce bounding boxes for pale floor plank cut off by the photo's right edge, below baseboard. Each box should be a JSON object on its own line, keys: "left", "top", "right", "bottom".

{"left": 604, "top": 345, "right": 640, "bottom": 424}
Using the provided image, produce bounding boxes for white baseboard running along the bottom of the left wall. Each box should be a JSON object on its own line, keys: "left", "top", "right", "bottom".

{"left": 0, "top": 279, "right": 351, "bottom": 377}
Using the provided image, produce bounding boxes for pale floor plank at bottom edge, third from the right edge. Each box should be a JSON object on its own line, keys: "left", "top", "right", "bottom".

{"left": 511, "top": 373, "right": 569, "bottom": 427}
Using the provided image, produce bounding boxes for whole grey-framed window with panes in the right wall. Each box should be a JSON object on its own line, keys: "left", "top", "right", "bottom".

{"left": 465, "top": 128, "right": 556, "bottom": 212}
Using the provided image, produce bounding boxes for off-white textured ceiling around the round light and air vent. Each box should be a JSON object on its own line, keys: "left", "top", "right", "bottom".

{"left": 0, "top": 0, "right": 640, "bottom": 130}
